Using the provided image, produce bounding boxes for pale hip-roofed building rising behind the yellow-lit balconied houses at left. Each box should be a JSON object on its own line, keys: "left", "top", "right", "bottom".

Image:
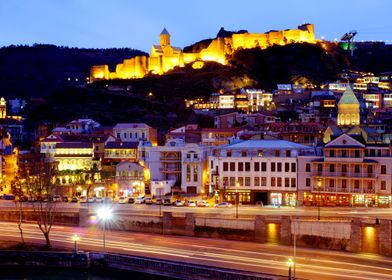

{"left": 113, "top": 123, "right": 158, "bottom": 146}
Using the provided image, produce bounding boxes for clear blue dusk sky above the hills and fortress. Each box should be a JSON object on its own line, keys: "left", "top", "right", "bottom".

{"left": 0, "top": 0, "right": 392, "bottom": 52}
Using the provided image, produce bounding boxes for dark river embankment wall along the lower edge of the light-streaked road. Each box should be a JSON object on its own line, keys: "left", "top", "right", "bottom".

{"left": 0, "top": 251, "right": 286, "bottom": 280}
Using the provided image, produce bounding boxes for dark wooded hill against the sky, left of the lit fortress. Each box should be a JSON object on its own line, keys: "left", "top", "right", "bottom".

{"left": 0, "top": 44, "right": 146, "bottom": 98}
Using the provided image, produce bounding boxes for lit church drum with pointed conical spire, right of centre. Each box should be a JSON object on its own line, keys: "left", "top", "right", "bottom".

{"left": 338, "top": 85, "right": 360, "bottom": 126}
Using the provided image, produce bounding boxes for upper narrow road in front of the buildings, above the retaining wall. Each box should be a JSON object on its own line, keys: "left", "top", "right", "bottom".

{"left": 0, "top": 200, "right": 392, "bottom": 219}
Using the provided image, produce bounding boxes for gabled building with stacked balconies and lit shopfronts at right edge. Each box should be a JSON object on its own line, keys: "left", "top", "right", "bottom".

{"left": 298, "top": 133, "right": 392, "bottom": 207}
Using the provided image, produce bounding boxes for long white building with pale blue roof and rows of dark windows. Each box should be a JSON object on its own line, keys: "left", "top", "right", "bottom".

{"left": 208, "top": 140, "right": 313, "bottom": 206}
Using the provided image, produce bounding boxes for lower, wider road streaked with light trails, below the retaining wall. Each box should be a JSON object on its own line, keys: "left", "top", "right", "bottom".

{"left": 0, "top": 222, "right": 392, "bottom": 280}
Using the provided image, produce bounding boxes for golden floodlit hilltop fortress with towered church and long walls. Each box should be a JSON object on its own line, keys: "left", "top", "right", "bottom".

{"left": 90, "top": 24, "right": 315, "bottom": 81}
